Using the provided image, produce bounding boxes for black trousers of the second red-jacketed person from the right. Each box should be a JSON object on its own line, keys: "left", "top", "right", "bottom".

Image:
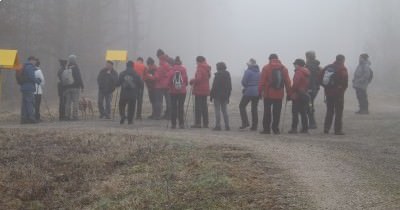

{"left": 292, "top": 96, "right": 309, "bottom": 132}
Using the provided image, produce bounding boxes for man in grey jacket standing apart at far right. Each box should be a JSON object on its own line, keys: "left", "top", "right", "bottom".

{"left": 353, "top": 54, "right": 373, "bottom": 114}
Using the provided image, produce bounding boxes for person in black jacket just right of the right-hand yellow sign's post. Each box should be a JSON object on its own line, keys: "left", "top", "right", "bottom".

{"left": 118, "top": 61, "right": 143, "bottom": 124}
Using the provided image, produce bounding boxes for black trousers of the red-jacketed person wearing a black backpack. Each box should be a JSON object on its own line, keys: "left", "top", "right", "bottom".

{"left": 263, "top": 99, "right": 282, "bottom": 133}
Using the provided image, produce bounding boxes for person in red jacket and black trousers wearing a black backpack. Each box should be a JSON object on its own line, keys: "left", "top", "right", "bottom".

{"left": 258, "top": 54, "right": 291, "bottom": 134}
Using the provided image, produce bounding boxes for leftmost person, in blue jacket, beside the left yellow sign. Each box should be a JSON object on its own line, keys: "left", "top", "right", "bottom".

{"left": 20, "top": 56, "right": 41, "bottom": 124}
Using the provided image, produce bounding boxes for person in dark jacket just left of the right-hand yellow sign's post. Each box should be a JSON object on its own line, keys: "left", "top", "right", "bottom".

{"left": 97, "top": 61, "right": 118, "bottom": 119}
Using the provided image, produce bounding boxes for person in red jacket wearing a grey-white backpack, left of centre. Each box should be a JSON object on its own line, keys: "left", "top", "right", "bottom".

{"left": 168, "top": 56, "right": 188, "bottom": 129}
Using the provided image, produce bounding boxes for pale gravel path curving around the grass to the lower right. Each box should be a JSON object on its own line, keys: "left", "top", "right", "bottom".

{"left": 0, "top": 101, "right": 400, "bottom": 209}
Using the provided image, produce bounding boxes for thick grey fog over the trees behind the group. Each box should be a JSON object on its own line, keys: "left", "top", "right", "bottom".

{"left": 0, "top": 0, "right": 400, "bottom": 106}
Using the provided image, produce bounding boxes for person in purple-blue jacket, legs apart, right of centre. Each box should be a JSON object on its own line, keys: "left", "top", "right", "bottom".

{"left": 239, "top": 59, "right": 260, "bottom": 131}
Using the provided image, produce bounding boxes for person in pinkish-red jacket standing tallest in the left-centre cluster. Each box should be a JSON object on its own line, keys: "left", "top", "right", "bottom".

{"left": 154, "top": 50, "right": 171, "bottom": 120}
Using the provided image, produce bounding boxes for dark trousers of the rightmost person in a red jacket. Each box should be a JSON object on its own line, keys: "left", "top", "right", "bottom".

{"left": 324, "top": 95, "right": 344, "bottom": 132}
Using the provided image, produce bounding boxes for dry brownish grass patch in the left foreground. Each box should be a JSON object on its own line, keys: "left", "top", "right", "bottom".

{"left": 0, "top": 129, "right": 287, "bottom": 209}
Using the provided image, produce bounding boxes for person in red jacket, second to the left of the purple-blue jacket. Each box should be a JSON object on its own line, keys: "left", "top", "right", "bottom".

{"left": 190, "top": 56, "right": 211, "bottom": 128}
